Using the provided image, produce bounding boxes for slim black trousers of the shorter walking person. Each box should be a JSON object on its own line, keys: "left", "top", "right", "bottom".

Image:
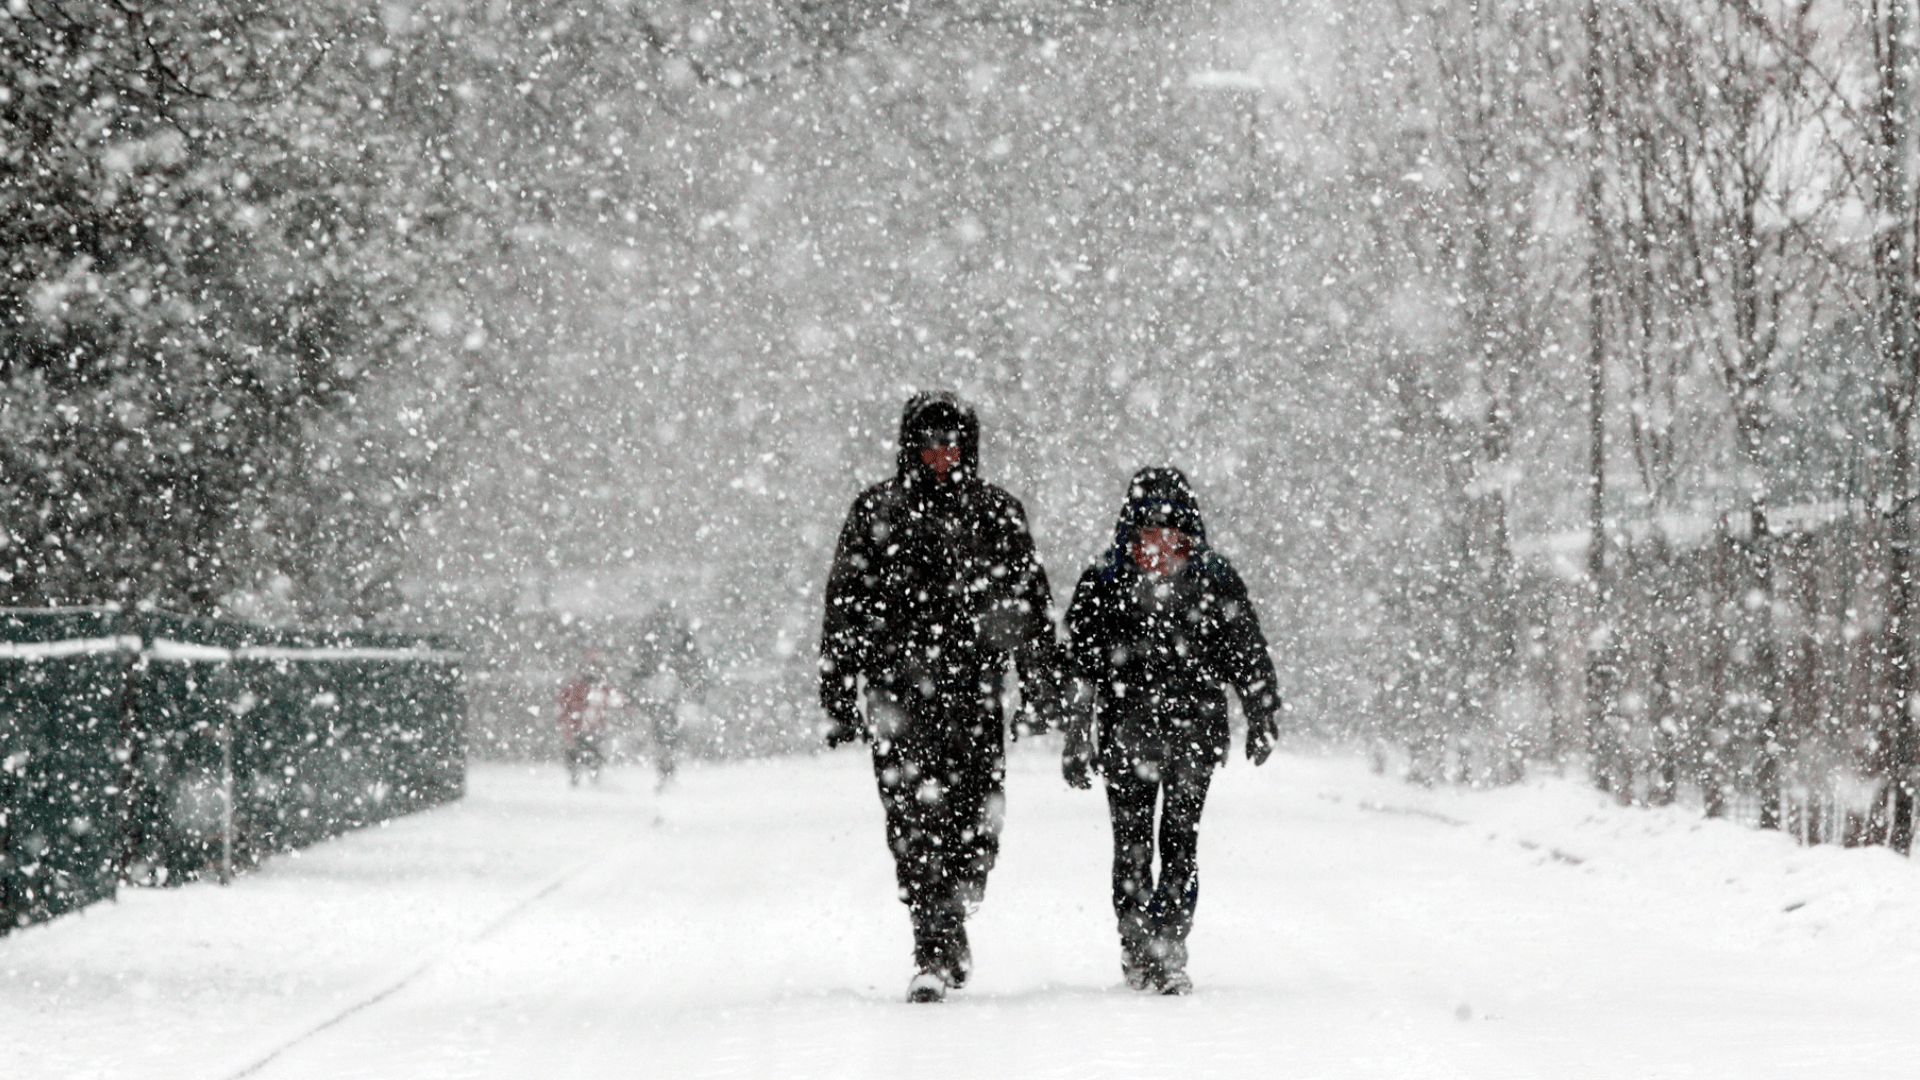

{"left": 1106, "top": 755, "right": 1213, "bottom": 942}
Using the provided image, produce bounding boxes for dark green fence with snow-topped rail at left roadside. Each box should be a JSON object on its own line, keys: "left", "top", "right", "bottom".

{"left": 0, "top": 611, "right": 467, "bottom": 932}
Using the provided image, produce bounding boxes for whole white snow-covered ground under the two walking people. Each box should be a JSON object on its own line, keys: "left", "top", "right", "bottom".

{"left": 11, "top": 740, "right": 1920, "bottom": 1080}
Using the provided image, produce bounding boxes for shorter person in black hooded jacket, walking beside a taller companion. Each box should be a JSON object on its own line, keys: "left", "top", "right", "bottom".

{"left": 1064, "top": 467, "right": 1281, "bottom": 994}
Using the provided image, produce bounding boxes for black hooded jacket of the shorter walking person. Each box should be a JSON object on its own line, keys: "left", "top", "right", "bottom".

{"left": 1068, "top": 467, "right": 1281, "bottom": 774}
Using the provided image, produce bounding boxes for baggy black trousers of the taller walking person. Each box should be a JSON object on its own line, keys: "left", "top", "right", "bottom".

{"left": 874, "top": 701, "right": 1006, "bottom": 969}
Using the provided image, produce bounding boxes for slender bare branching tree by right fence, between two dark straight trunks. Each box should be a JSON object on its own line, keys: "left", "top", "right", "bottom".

{"left": 1622, "top": 2, "right": 1839, "bottom": 828}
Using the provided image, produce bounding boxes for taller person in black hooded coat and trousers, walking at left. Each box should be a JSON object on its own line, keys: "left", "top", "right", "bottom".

{"left": 820, "top": 394, "right": 1066, "bottom": 1001}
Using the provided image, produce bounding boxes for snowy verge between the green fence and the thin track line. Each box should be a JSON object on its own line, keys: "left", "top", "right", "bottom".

{"left": 0, "top": 767, "right": 618, "bottom": 1078}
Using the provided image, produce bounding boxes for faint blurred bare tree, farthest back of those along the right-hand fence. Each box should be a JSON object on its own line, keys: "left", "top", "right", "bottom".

{"left": 1390, "top": 2, "right": 1576, "bottom": 774}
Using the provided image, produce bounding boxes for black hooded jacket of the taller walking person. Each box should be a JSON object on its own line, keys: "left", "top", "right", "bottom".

{"left": 820, "top": 392, "right": 1066, "bottom": 738}
